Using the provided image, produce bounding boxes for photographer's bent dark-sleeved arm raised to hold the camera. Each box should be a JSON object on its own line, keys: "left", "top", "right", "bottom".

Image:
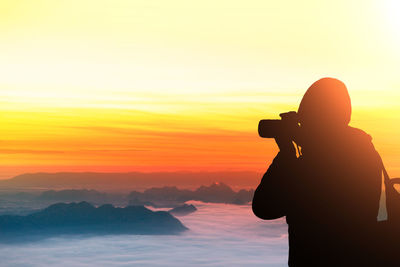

{"left": 252, "top": 138, "right": 297, "bottom": 220}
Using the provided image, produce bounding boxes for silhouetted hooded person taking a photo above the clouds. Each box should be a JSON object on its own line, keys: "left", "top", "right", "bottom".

{"left": 253, "top": 78, "right": 382, "bottom": 266}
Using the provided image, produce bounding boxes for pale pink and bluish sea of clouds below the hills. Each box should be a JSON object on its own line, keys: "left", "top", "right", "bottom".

{"left": 0, "top": 201, "right": 288, "bottom": 266}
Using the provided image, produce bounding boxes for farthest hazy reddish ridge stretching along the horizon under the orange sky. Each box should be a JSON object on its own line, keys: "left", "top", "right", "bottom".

{"left": 0, "top": 172, "right": 260, "bottom": 191}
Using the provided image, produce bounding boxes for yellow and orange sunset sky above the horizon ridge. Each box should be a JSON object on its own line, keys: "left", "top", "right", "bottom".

{"left": 0, "top": 0, "right": 400, "bottom": 179}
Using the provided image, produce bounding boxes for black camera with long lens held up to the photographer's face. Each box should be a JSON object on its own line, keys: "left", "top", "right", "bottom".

{"left": 258, "top": 111, "right": 299, "bottom": 138}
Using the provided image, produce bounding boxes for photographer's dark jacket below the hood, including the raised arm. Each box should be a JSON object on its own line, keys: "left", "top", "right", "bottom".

{"left": 253, "top": 127, "right": 382, "bottom": 266}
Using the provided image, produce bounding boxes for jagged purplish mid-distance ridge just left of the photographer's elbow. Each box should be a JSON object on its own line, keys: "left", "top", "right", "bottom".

{"left": 128, "top": 183, "right": 254, "bottom": 207}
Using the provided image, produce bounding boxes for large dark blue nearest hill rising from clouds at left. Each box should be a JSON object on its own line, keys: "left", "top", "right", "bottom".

{"left": 0, "top": 202, "right": 187, "bottom": 238}
